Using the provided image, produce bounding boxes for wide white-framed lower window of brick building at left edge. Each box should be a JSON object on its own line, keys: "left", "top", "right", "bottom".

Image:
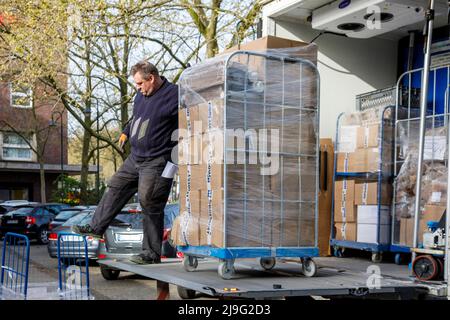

{"left": 2, "top": 132, "right": 33, "bottom": 161}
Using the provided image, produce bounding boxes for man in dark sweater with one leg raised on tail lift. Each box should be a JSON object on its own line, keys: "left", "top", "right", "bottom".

{"left": 72, "top": 61, "right": 178, "bottom": 264}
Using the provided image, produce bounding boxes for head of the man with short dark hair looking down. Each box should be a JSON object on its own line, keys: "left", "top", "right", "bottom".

{"left": 131, "top": 61, "right": 162, "bottom": 96}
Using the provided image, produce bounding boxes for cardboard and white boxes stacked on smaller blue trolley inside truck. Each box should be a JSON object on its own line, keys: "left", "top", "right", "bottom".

{"left": 334, "top": 108, "right": 393, "bottom": 244}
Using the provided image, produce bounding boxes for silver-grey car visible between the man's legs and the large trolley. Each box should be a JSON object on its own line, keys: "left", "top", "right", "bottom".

{"left": 98, "top": 203, "right": 179, "bottom": 280}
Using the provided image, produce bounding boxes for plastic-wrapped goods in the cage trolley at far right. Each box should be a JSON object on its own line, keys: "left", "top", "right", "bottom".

{"left": 394, "top": 124, "right": 448, "bottom": 247}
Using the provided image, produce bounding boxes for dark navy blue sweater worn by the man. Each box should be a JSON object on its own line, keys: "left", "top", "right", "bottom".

{"left": 123, "top": 77, "right": 178, "bottom": 158}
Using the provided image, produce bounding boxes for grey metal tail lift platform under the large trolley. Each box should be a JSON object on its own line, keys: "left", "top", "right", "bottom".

{"left": 99, "top": 258, "right": 429, "bottom": 299}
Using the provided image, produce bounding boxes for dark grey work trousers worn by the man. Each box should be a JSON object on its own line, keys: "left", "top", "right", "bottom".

{"left": 91, "top": 155, "right": 173, "bottom": 258}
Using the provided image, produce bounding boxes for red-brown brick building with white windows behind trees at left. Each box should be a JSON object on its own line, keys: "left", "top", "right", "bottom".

{"left": 0, "top": 83, "right": 96, "bottom": 201}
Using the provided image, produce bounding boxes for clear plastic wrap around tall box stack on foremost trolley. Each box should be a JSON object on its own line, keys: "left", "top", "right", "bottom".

{"left": 171, "top": 47, "right": 319, "bottom": 247}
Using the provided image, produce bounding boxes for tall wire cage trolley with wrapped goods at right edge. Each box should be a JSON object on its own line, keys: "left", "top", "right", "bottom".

{"left": 391, "top": 65, "right": 450, "bottom": 271}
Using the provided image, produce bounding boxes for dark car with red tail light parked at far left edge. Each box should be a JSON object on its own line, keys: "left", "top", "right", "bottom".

{"left": 0, "top": 204, "right": 56, "bottom": 244}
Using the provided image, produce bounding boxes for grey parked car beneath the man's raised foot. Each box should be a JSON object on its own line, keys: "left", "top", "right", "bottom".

{"left": 47, "top": 209, "right": 103, "bottom": 260}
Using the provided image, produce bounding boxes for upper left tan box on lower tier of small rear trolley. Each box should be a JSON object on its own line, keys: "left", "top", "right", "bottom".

{"left": 334, "top": 179, "right": 356, "bottom": 222}
